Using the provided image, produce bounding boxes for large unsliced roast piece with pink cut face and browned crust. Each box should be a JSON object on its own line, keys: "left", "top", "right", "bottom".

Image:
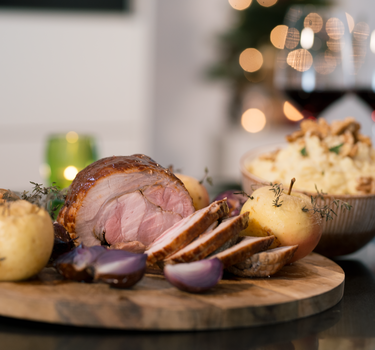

{"left": 57, "top": 154, "right": 194, "bottom": 246}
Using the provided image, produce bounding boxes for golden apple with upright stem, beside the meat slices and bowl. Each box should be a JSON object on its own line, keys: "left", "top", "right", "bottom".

{"left": 241, "top": 186, "right": 323, "bottom": 262}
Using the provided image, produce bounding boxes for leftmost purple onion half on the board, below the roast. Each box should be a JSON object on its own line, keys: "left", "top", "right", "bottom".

{"left": 54, "top": 245, "right": 107, "bottom": 282}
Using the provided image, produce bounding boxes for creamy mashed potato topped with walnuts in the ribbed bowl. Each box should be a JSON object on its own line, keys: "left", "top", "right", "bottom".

{"left": 245, "top": 118, "right": 375, "bottom": 195}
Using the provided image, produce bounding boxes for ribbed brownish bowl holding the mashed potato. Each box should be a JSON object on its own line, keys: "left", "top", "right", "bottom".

{"left": 240, "top": 144, "right": 375, "bottom": 257}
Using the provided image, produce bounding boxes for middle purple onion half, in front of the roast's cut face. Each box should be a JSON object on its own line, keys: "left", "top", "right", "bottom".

{"left": 90, "top": 249, "right": 147, "bottom": 288}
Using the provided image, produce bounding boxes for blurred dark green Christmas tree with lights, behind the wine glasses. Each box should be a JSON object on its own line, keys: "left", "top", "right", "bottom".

{"left": 208, "top": 0, "right": 332, "bottom": 122}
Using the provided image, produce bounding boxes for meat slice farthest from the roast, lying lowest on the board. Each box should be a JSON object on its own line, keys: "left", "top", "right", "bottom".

{"left": 227, "top": 245, "right": 298, "bottom": 277}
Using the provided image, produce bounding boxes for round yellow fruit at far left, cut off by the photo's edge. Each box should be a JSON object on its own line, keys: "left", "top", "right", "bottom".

{"left": 0, "top": 200, "right": 54, "bottom": 281}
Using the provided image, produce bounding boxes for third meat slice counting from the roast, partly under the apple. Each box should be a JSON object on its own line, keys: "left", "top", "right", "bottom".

{"left": 210, "top": 236, "right": 274, "bottom": 268}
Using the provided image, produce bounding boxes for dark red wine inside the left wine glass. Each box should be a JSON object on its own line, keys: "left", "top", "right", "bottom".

{"left": 284, "top": 89, "right": 346, "bottom": 118}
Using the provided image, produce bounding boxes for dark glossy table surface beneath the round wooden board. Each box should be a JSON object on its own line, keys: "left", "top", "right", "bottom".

{"left": 0, "top": 240, "right": 375, "bottom": 350}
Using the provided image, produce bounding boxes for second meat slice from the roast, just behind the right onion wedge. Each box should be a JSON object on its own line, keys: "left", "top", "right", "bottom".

{"left": 165, "top": 212, "right": 249, "bottom": 264}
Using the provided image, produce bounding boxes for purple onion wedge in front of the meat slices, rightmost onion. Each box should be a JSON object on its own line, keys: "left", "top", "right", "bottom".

{"left": 164, "top": 258, "right": 223, "bottom": 293}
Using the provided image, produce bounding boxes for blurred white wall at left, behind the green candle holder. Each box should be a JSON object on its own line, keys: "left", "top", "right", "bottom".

{"left": 0, "top": 0, "right": 155, "bottom": 190}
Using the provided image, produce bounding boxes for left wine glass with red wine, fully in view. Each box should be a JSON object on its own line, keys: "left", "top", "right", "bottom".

{"left": 275, "top": 6, "right": 355, "bottom": 119}
